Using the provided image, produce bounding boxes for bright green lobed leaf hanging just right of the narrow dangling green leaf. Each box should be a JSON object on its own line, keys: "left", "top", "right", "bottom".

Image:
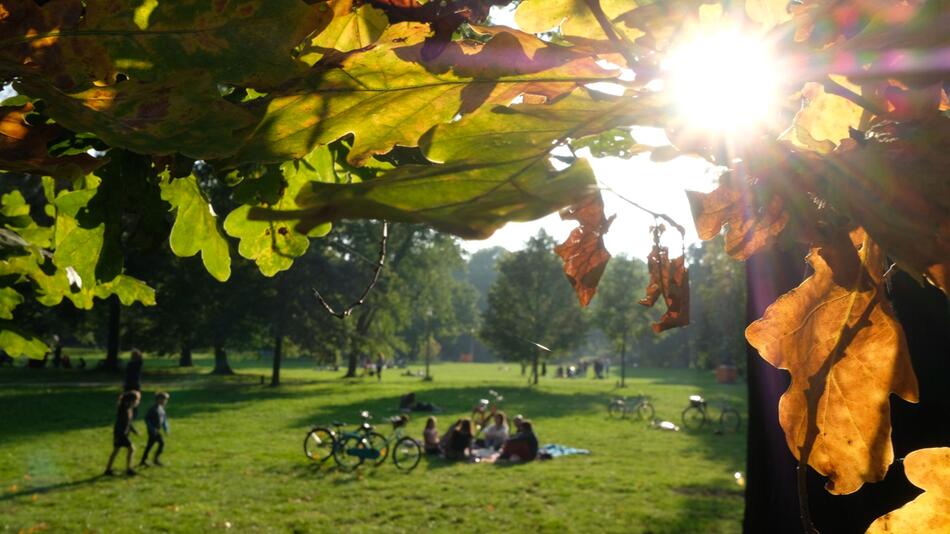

{"left": 224, "top": 147, "right": 336, "bottom": 276}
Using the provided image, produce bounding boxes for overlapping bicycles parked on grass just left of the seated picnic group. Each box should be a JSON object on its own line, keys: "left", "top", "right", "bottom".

{"left": 304, "top": 411, "right": 422, "bottom": 471}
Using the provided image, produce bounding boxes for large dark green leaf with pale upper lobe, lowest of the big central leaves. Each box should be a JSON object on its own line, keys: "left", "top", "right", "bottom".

{"left": 249, "top": 91, "right": 655, "bottom": 238}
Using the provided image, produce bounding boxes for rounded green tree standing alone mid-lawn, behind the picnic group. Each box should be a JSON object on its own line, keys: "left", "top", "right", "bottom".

{"left": 480, "top": 230, "right": 587, "bottom": 384}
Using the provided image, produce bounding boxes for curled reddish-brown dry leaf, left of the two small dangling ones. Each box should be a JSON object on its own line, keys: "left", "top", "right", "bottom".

{"left": 554, "top": 191, "right": 616, "bottom": 306}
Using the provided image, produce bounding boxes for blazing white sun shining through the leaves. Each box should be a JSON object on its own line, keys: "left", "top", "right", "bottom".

{"left": 663, "top": 29, "right": 781, "bottom": 133}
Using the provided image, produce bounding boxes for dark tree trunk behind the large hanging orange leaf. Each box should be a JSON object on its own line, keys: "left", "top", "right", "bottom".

{"left": 744, "top": 253, "right": 950, "bottom": 533}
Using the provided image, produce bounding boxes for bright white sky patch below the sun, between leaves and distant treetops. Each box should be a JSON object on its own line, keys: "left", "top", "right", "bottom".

{"left": 462, "top": 134, "right": 717, "bottom": 258}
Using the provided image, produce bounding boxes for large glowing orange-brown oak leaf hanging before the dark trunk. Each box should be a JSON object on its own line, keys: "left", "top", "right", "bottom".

{"left": 746, "top": 229, "right": 917, "bottom": 494}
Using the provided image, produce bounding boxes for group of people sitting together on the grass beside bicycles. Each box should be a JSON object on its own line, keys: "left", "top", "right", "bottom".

{"left": 423, "top": 411, "right": 538, "bottom": 462}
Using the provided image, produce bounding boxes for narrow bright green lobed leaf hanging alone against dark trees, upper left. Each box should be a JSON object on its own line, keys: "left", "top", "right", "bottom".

{"left": 161, "top": 175, "right": 231, "bottom": 282}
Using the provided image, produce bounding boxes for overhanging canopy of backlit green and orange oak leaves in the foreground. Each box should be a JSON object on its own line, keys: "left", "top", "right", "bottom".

{"left": 0, "top": 0, "right": 950, "bottom": 528}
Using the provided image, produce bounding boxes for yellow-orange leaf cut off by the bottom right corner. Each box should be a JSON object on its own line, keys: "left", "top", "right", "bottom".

{"left": 868, "top": 447, "right": 950, "bottom": 534}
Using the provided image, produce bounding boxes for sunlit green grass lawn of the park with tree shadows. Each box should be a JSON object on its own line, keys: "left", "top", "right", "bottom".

{"left": 0, "top": 358, "right": 746, "bottom": 533}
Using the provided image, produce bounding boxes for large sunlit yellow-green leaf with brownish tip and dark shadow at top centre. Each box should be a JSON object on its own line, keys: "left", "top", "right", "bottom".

{"left": 220, "top": 24, "right": 618, "bottom": 167}
